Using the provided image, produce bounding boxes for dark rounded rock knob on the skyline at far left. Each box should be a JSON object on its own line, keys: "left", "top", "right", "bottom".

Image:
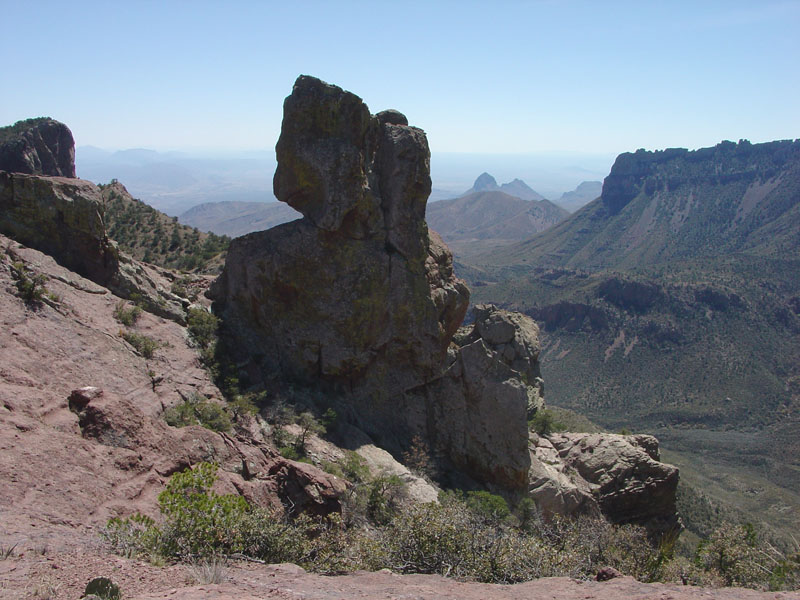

{"left": 0, "top": 118, "right": 75, "bottom": 177}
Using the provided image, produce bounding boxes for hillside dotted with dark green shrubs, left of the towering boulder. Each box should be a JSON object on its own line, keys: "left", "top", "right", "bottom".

{"left": 98, "top": 179, "right": 230, "bottom": 271}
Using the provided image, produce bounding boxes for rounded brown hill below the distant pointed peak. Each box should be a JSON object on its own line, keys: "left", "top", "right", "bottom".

{"left": 426, "top": 191, "right": 569, "bottom": 258}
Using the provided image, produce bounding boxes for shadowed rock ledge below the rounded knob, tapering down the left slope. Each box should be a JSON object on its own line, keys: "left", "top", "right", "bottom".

{"left": 0, "top": 171, "right": 184, "bottom": 322}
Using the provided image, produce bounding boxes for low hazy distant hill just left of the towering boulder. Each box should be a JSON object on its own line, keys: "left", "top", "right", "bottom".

{"left": 178, "top": 202, "right": 300, "bottom": 237}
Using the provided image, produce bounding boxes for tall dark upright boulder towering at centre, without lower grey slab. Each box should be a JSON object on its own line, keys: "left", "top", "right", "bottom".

{"left": 211, "top": 76, "right": 476, "bottom": 454}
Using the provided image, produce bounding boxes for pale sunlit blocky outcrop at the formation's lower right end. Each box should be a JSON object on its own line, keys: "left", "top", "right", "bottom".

{"left": 529, "top": 433, "right": 680, "bottom": 534}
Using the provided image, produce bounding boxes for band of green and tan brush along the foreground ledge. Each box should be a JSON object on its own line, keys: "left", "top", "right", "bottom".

{"left": 104, "top": 463, "right": 800, "bottom": 589}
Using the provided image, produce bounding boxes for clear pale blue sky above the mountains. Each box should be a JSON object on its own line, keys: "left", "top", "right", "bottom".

{"left": 0, "top": 0, "right": 800, "bottom": 154}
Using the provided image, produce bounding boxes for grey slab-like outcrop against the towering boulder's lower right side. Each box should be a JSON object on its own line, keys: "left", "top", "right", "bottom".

{"left": 421, "top": 305, "right": 543, "bottom": 490}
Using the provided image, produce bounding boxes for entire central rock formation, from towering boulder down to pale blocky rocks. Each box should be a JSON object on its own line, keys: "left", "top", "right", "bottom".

{"left": 210, "top": 76, "right": 676, "bottom": 520}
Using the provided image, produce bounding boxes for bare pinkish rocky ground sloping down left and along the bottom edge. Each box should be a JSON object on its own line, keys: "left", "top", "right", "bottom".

{"left": 0, "top": 236, "right": 800, "bottom": 600}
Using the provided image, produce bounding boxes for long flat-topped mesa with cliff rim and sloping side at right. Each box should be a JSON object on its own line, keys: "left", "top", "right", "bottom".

{"left": 494, "top": 140, "right": 800, "bottom": 269}
